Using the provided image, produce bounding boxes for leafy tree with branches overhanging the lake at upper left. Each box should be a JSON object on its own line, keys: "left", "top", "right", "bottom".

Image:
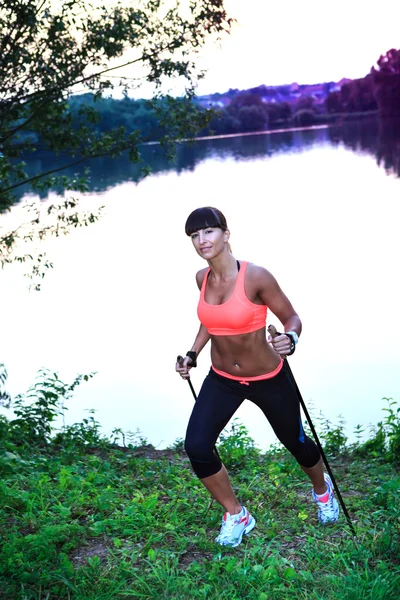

{"left": 0, "top": 0, "right": 232, "bottom": 286}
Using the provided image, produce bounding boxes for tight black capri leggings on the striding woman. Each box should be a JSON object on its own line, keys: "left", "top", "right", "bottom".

{"left": 185, "top": 369, "right": 320, "bottom": 479}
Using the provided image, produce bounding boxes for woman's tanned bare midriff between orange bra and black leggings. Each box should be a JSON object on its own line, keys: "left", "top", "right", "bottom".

{"left": 211, "top": 327, "right": 281, "bottom": 378}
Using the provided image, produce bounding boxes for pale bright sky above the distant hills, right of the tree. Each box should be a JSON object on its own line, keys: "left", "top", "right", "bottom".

{"left": 130, "top": 0, "right": 400, "bottom": 95}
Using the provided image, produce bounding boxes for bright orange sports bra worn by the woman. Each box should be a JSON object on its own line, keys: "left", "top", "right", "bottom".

{"left": 197, "top": 261, "right": 267, "bottom": 335}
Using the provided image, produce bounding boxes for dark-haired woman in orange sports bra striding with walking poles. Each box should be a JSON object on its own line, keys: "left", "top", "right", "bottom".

{"left": 176, "top": 207, "right": 339, "bottom": 547}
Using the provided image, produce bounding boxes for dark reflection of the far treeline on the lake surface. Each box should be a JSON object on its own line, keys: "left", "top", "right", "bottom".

{"left": 18, "top": 119, "right": 400, "bottom": 204}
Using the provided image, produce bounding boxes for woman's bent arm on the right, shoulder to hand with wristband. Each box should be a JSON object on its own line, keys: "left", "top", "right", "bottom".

{"left": 252, "top": 266, "right": 302, "bottom": 355}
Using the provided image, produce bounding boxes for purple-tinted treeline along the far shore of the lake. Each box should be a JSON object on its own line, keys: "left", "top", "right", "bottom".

{"left": 69, "top": 50, "right": 400, "bottom": 141}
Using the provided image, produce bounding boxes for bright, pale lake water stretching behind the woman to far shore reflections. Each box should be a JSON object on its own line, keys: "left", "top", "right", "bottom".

{"left": 0, "top": 123, "right": 400, "bottom": 448}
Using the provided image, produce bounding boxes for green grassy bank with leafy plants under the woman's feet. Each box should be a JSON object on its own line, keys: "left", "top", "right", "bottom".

{"left": 0, "top": 371, "right": 400, "bottom": 600}
